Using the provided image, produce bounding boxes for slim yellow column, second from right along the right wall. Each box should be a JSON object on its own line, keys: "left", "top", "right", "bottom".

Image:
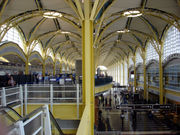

{"left": 143, "top": 57, "right": 148, "bottom": 101}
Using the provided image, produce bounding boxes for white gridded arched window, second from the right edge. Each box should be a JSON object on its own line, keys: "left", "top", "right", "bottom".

{"left": 146, "top": 42, "right": 159, "bottom": 62}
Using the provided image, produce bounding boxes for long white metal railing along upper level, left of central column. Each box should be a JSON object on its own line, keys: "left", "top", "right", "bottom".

{"left": 0, "top": 84, "right": 82, "bottom": 115}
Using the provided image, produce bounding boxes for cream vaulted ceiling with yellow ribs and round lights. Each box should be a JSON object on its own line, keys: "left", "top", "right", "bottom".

{"left": 0, "top": 0, "right": 180, "bottom": 66}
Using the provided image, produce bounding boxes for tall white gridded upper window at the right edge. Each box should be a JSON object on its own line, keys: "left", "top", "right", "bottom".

{"left": 163, "top": 27, "right": 180, "bottom": 59}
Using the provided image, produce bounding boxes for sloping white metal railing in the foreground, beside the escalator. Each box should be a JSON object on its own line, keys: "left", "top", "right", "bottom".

{"left": 8, "top": 105, "right": 63, "bottom": 135}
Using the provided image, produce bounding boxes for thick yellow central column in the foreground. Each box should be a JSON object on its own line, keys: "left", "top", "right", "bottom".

{"left": 82, "top": 18, "right": 95, "bottom": 135}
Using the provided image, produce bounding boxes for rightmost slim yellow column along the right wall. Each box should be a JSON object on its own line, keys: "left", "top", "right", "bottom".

{"left": 159, "top": 53, "right": 164, "bottom": 104}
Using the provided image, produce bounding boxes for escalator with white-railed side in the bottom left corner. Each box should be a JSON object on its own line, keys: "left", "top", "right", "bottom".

{"left": 0, "top": 106, "right": 64, "bottom": 135}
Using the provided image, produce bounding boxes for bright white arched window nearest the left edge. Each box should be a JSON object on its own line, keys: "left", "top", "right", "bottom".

{"left": 2, "top": 28, "right": 24, "bottom": 50}
